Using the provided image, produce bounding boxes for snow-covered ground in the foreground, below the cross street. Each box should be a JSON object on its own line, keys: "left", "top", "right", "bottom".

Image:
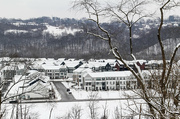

{"left": 4, "top": 100, "right": 146, "bottom": 119}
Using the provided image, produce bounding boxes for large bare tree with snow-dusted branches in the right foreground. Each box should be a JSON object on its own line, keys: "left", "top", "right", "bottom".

{"left": 74, "top": 0, "right": 180, "bottom": 119}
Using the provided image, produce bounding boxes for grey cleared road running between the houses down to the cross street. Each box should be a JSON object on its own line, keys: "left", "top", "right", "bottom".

{"left": 53, "top": 82, "right": 76, "bottom": 102}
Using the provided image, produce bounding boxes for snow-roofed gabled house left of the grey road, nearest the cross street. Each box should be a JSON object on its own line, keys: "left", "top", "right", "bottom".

{"left": 5, "top": 70, "right": 54, "bottom": 100}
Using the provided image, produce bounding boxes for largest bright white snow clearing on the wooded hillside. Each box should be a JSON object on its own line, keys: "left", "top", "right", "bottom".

{"left": 43, "top": 25, "right": 81, "bottom": 36}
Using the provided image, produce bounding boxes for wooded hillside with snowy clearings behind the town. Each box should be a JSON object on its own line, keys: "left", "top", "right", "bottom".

{"left": 0, "top": 17, "right": 180, "bottom": 59}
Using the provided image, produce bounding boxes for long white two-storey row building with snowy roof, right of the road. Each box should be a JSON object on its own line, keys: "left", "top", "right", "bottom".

{"left": 82, "top": 71, "right": 137, "bottom": 90}
